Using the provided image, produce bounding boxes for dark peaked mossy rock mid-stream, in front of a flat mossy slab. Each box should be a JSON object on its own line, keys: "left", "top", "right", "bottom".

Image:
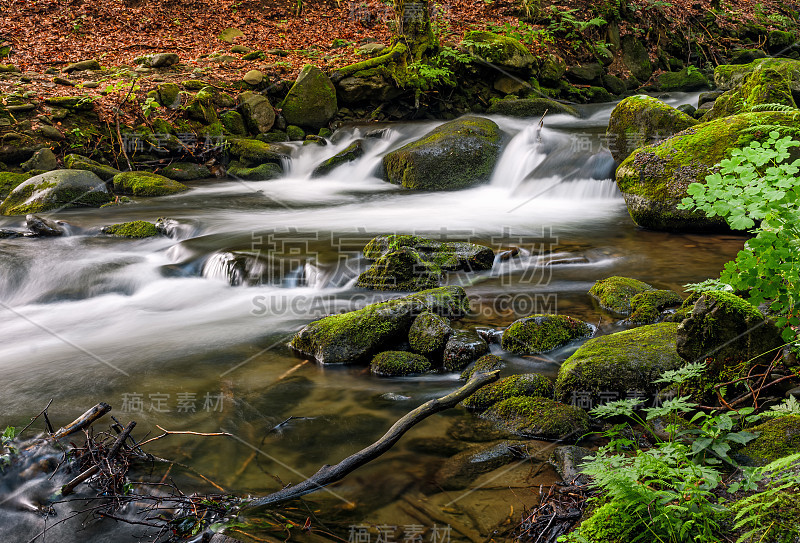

{"left": 356, "top": 247, "right": 442, "bottom": 291}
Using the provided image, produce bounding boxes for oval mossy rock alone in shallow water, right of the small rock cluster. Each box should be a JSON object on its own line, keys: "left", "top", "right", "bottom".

{"left": 502, "top": 315, "right": 592, "bottom": 354}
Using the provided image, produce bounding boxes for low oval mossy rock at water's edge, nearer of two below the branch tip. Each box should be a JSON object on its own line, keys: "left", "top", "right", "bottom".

{"left": 482, "top": 396, "right": 589, "bottom": 441}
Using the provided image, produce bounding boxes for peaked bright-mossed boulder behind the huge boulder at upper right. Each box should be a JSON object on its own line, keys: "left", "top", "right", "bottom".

{"left": 703, "top": 66, "right": 797, "bottom": 121}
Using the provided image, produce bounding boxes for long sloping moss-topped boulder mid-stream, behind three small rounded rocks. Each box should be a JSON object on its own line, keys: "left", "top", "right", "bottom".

{"left": 289, "top": 286, "right": 469, "bottom": 364}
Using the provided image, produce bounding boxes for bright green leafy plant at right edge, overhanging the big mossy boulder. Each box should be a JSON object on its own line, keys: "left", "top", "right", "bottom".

{"left": 679, "top": 131, "right": 800, "bottom": 341}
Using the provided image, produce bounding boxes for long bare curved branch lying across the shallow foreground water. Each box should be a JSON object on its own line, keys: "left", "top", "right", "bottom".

{"left": 245, "top": 371, "right": 500, "bottom": 509}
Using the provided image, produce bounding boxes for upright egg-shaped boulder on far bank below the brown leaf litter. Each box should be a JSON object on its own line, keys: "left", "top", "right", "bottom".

{"left": 281, "top": 64, "right": 338, "bottom": 130}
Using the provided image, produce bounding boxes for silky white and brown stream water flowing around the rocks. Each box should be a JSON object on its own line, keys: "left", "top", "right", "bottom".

{"left": 0, "top": 95, "right": 742, "bottom": 541}
